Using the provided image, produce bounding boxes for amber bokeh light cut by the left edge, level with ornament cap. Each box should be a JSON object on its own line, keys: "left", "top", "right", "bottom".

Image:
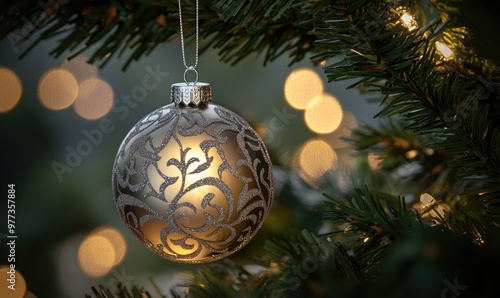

{"left": 0, "top": 67, "right": 23, "bottom": 113}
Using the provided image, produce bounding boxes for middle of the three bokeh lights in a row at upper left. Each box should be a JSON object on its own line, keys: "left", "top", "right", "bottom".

{"left": 38, "top": 68, "right": 78, "bottom": 110}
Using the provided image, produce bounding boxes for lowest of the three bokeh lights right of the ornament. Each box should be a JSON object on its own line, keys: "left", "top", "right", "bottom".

{"left": 297, "top": 139, "right": 337, "bottom": 185}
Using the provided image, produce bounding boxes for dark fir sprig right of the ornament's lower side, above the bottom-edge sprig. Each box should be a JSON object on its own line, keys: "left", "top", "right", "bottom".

{"left": 321, "top": 186, "right": 426, "bottom": 278}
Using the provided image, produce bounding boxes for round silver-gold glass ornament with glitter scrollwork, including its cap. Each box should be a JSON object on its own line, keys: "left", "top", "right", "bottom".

{"left": 113, "top": 83, "right": 273, "bottom": 263}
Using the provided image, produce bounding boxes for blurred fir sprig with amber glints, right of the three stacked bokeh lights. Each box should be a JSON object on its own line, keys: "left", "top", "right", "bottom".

{"left": 349, "top": 121, "right": 459, "bottom": 200}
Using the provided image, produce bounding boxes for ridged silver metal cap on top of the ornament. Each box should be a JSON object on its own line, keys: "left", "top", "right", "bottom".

{"left": 170, "top": 82, "right": 212, "bottom": 108}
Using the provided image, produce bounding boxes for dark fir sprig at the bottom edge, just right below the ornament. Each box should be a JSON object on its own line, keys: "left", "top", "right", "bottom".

{"left": 259, "top": 230, "right": 369, "bottom": 297}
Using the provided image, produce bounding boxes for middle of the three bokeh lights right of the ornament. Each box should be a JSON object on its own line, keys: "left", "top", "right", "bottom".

{"left": 304, "top": 94, "right": 343, "bottom": 134}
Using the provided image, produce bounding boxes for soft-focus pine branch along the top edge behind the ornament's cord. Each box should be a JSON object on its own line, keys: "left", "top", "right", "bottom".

{"left": 0, "top": 0, "right": 320, "bottom": 70}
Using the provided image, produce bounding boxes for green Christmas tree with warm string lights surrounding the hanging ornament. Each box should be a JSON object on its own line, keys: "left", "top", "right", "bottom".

{"left": 0, "top": 0, "right": 500, "bottom": 297}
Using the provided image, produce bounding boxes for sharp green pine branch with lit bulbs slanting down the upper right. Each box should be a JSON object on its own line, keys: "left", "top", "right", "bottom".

{"left": 308, "top": 1, "right": 500, "bottom": 237}
